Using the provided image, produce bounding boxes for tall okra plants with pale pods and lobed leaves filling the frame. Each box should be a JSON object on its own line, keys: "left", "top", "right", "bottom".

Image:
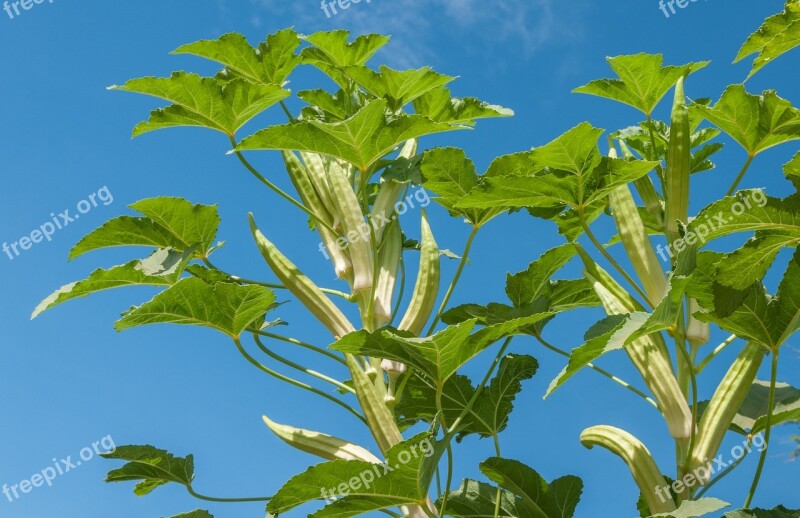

{"left": 34, "top": 0, "right": 800, "bottom": 518}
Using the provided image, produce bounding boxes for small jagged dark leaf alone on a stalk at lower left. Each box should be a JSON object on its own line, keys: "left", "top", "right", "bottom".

{"left": 101, "top": 446, "right": 194, "bottom": 496}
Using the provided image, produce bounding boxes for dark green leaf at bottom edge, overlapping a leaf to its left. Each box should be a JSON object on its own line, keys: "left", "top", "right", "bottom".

{"left": 480, "top": 457, "right": 583, "bottom": 518}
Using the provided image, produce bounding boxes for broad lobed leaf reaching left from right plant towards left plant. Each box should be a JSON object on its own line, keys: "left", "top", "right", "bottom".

{"left": 458, "top": 123, "right": 656, "bottom": 215}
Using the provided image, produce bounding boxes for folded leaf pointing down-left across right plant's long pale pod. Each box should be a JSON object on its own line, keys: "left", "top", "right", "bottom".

{"left": 545, "top": 313, "right": 649, "bottom": 397}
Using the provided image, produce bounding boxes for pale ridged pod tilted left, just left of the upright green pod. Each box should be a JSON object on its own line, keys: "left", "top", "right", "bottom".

{"left": 608, "top": 148, "right": 669, "bottom": 306}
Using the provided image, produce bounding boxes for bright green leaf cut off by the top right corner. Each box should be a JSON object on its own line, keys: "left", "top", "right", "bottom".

{"left": 734, "top": 0, "right": 800, "bottom": 79}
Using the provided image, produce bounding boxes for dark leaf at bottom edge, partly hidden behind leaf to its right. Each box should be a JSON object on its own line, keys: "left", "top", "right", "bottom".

{"left": 436, "top": 479, "right": 527, "bottom": 518}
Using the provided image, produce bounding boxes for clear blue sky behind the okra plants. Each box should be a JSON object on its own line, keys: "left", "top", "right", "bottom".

{"left": 0, "top": 0, "right": 800, "bottom": 518}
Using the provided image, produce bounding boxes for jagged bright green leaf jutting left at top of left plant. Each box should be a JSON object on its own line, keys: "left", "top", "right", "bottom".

{"left": 109, "top": 72, "right": 290, "bottom": 137}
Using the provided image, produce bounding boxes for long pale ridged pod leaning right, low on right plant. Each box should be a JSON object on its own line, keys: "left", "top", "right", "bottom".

{"left": 692, "top": 342, "right": 767, "bottom": 483}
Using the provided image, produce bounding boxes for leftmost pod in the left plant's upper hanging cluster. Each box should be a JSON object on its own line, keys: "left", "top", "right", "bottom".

{"left": 283, "top": 151, "right": 353, "bottom": 287}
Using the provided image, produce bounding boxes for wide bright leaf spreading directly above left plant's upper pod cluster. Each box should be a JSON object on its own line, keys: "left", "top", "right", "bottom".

{"left": 236, "top": 99, "right": 459, "bottom": 171}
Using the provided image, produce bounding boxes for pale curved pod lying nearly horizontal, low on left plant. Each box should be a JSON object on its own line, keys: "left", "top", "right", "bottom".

{"left": 263, "top": 416, "right": 381, "bottom": 464}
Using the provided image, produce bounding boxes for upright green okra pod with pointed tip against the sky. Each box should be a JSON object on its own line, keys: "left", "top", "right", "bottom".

{"left": 664, "top": 77, "right": 692, "bottom": 248}
